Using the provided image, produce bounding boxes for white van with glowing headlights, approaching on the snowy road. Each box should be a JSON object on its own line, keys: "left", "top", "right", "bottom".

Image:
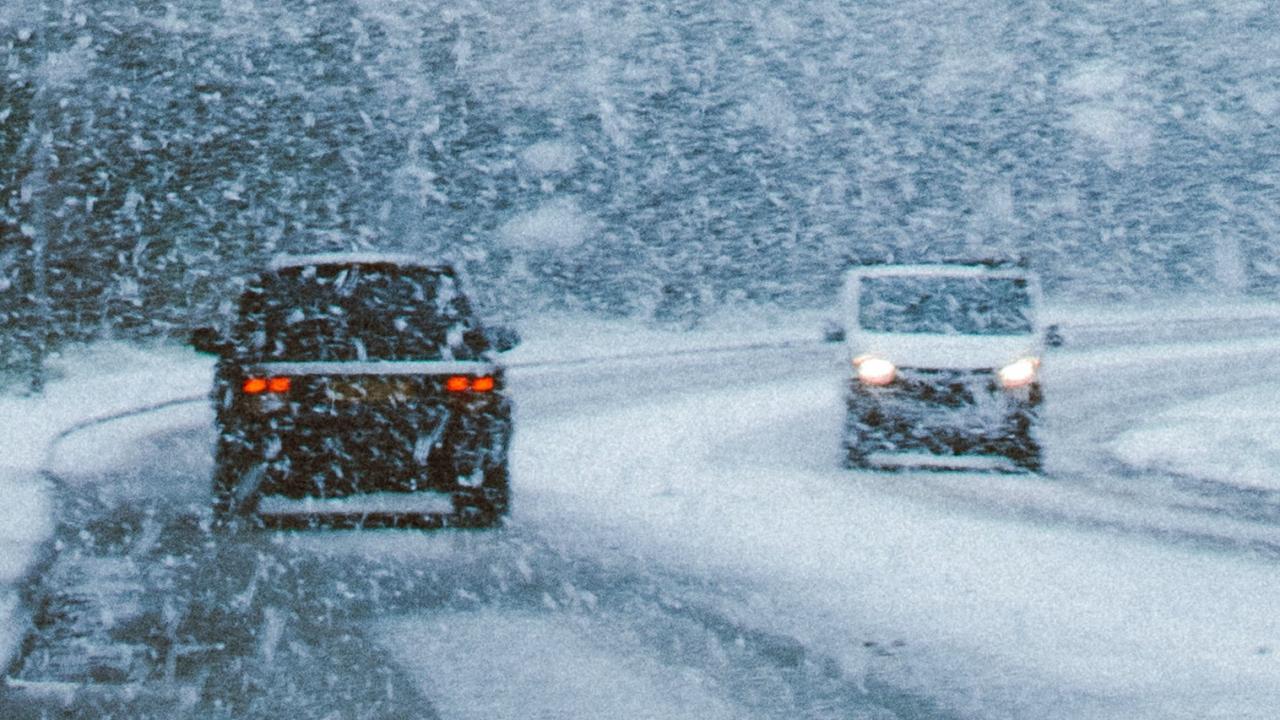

{"left": 842, "top": 261, "right": 1044, "bottom": 471}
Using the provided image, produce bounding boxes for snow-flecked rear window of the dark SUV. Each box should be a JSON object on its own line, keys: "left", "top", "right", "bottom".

{"left": 236, "top": 264, "right": 484, "bottom": 361}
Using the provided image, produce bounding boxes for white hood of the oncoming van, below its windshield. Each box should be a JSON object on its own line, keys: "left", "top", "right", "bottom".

{"left": 849, "top": 332, "right": 1042, "bottom": 370}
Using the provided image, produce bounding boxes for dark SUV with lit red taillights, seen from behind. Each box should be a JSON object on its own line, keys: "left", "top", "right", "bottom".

{"left": 192, "top": 254, "right": 517, "bottom": 525}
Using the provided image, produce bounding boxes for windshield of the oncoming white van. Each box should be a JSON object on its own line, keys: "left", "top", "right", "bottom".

{"left": 858, "top": 275, "right": 1034, "bottom": 334}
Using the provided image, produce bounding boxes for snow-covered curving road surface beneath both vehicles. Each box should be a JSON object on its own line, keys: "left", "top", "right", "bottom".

{"left": 0, "top": 312, "right": 1280, "bottom": 719}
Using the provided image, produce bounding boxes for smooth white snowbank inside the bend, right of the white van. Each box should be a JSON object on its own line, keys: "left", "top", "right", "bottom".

{"left": 1111, "top": 382, "right": 1280, "bottom": 491}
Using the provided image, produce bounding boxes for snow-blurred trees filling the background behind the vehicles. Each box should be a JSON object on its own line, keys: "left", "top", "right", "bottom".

{"left": 0, "top": 0, "right": 1280, "bottom": 376}
